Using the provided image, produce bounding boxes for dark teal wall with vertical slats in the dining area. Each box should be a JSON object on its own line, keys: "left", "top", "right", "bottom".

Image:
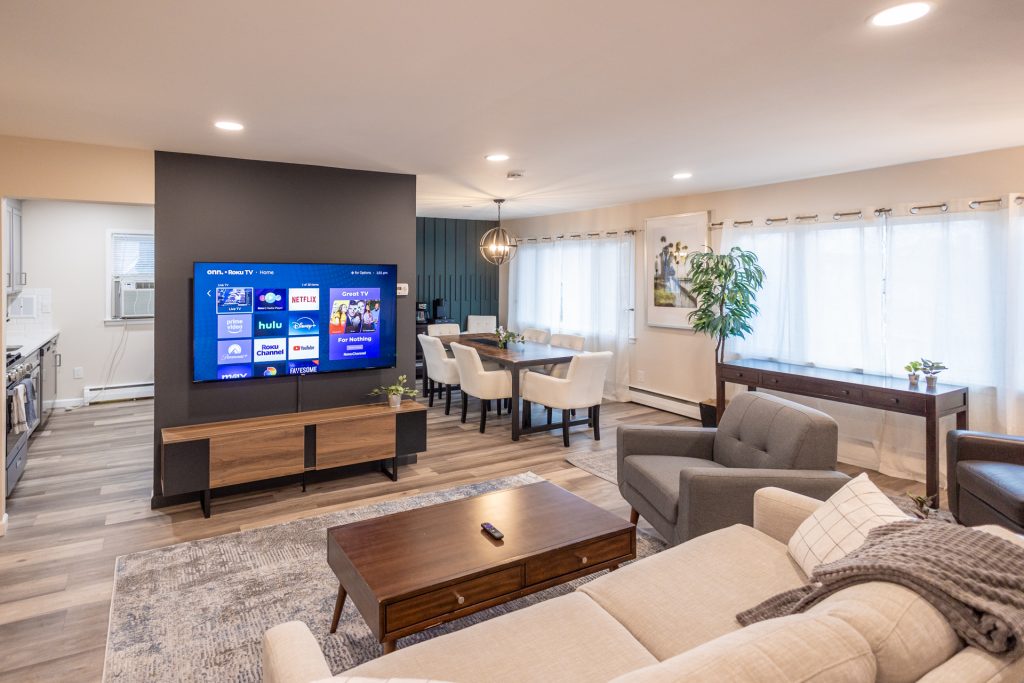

{"left": 416, "top": 218, "right": 498, "bottom": 329}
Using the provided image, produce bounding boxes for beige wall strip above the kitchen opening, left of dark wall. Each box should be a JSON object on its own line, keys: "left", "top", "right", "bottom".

{"left": 0, "top": 136, "right": 156, "bottom": 532}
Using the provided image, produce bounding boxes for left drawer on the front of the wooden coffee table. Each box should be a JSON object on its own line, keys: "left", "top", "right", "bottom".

{"left": 385, "top": 566, "right": 522, "bottom": 632}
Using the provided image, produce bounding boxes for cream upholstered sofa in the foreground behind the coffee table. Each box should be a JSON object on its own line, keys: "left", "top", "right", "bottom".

{"left": 263, "top": 488, "right": 1024, "bottom": 683}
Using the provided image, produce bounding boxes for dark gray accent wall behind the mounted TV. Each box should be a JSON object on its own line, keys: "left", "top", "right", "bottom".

{"left": 154, "top": 152, "right": 416, "bottom": 505}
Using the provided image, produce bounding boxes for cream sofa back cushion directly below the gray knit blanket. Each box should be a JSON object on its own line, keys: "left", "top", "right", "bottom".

{"left": 807, "top": 582, "right": 964, "bottom": 683}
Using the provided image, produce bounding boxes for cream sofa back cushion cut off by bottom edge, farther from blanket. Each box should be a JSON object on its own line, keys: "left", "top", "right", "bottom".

{"left": 612, "top": 614, "right": 874, "bottom": 683}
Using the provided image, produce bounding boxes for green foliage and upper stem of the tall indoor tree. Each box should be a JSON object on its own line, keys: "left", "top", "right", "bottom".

{"left": 689, "top": 247, "right": 765, "bottom": 362}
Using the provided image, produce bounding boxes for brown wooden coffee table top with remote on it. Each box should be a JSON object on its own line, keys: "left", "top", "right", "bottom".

{"left": 328, "top": 481, "right": 633, "bottom": 603}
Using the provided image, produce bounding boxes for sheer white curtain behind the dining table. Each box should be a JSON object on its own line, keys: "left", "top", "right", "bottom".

{"left": 508, "top": 234, "right": 634, "bottom": 400}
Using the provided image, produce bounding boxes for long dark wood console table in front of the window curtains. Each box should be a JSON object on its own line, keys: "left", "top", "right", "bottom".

{"left": 716, "top": 358, "right": 968, "bottom": 504}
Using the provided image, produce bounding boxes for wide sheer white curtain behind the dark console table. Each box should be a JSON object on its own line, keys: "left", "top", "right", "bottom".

{"left": 723, "top": 198, "right": 1024, "bottom": 479}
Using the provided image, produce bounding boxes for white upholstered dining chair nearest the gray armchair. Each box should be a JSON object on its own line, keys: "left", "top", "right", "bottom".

{"left": 521, "top": 351, "right": 611, "bottom": 447}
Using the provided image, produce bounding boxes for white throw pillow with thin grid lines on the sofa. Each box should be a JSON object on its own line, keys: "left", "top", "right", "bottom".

{"left": 790, "top": 474, "right": 907, "bottom": 577}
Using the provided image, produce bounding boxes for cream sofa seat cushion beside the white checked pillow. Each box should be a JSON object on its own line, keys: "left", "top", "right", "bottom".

{"left": 578, "top": 524, "right": 806, "bottom": 659}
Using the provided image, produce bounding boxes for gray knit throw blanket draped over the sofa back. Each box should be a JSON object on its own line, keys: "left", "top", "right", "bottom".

{"left": 736, "top": 519, "right": 1024, "bottom": 658}
